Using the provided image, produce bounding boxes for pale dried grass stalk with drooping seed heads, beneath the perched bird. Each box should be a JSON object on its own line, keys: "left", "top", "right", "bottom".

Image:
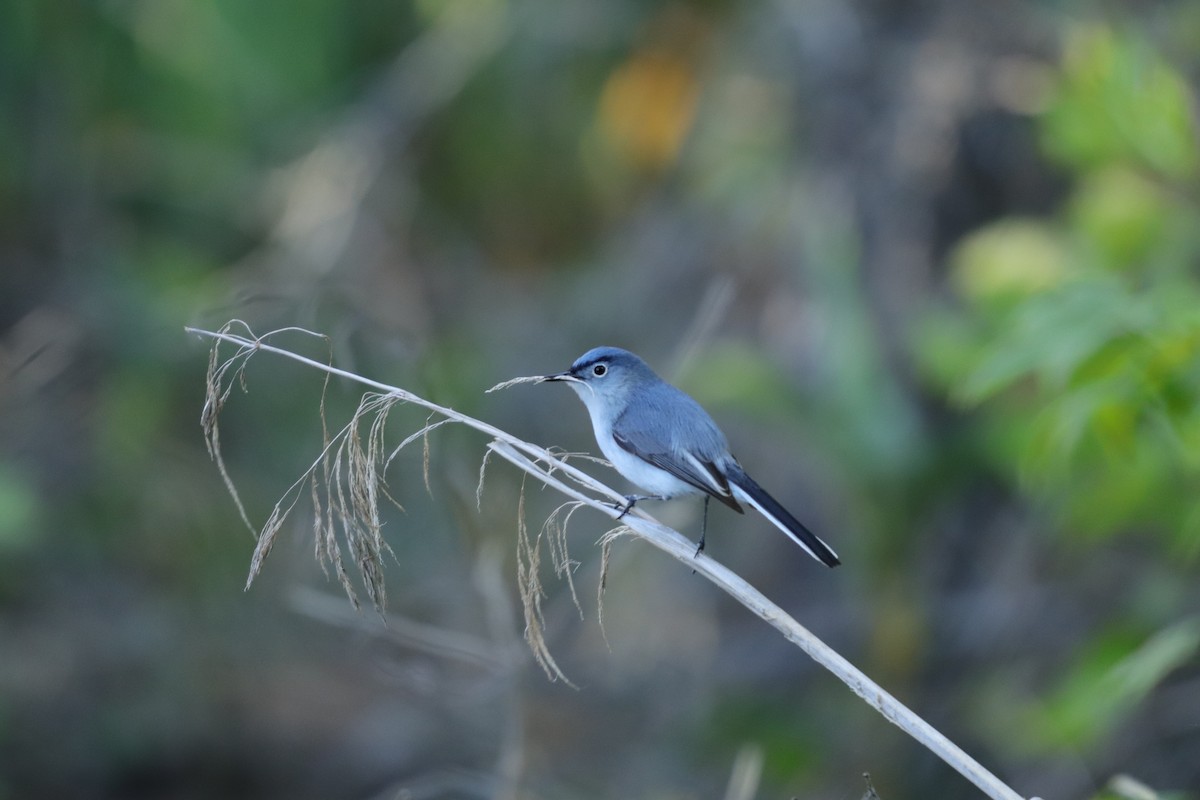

{"left": 186, "top": 320, "right": 1022, "bottom": 800}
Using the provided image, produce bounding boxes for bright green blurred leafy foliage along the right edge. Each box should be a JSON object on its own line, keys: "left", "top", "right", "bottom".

{"left": 916, "top": 26, "right": 1200, "bottom": 762}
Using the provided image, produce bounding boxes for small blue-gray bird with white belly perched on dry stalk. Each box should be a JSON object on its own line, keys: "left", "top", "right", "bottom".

{"left": 542, "top": 347, "right": 841, "bottom": 566}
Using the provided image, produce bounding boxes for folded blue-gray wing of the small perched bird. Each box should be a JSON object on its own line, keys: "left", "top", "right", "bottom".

{"left": 612, "top": 384, "right": 742, "bottom": 512}
